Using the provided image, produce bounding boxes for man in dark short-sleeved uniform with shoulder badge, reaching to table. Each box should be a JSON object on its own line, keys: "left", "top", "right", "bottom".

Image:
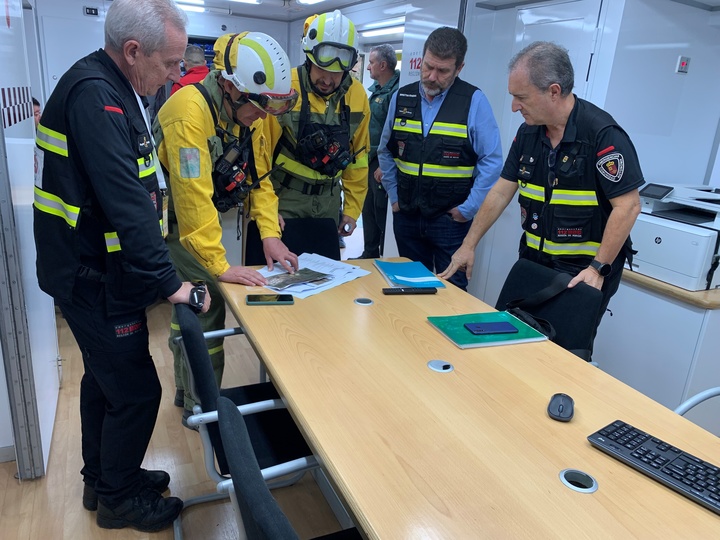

{"left": 440, "top": 42, "right": 644, "bottom": 354}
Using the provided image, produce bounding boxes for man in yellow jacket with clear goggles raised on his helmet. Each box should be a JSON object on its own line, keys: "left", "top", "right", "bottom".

{"left": 246, "top": 10, "right": 370, "bottom": 264}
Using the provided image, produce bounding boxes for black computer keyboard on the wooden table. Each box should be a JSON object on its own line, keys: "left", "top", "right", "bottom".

{"left": 588, "top": 420, "right": 720, "bottom": 514}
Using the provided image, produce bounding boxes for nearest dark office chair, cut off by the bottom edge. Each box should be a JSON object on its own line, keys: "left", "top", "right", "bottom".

{"left": 217, "top": 397, "right": 361, "bottom": 540}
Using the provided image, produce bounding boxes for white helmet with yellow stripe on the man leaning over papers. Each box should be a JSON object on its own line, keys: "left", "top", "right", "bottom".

{"left": 222, "top": 32, "right": 298, "bottom": 115}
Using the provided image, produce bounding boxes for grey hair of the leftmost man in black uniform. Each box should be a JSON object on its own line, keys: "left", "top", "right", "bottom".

{"left": 105, "top": 0, "right": 188, "bottom": 55}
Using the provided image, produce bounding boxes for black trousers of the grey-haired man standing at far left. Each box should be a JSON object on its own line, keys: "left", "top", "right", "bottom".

{"left": 58, "top": 279, "right": 162, "bottom": 508}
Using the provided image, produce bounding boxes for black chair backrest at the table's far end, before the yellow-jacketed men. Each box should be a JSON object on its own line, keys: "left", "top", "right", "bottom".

{"left": 243, "top": 218, "right": 340, "bottom": 266}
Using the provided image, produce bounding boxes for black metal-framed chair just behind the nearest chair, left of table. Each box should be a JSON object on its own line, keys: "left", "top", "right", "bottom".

{"left": 173, "top": 304, "right": 318, "bottom": 540}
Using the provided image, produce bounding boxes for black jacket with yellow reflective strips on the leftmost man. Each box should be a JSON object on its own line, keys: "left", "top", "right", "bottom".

{"left": 34, "top": 50, "right": 181, "bottom": 315}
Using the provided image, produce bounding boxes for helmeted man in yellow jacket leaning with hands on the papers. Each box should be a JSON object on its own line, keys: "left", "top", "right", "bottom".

{"left": 153, "top": 32, "right": 298, "bottom": 421}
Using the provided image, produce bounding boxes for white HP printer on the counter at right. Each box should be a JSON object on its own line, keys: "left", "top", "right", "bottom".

{"left": 631, "top": 184, "right": 720, "bottom": 291}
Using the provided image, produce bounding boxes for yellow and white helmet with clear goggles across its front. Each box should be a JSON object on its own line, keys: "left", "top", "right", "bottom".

{"left": 302, "top": 9, "right": 358, "bottom": 73}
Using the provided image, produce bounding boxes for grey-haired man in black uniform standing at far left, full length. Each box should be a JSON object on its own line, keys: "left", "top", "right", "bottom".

{"left": 34, "top": 0, "right": 210, "bottom": 531}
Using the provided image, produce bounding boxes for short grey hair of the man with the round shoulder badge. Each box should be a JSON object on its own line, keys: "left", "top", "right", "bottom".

{"left": 509, "top": 41, "right": 575, "bottom": 96}
